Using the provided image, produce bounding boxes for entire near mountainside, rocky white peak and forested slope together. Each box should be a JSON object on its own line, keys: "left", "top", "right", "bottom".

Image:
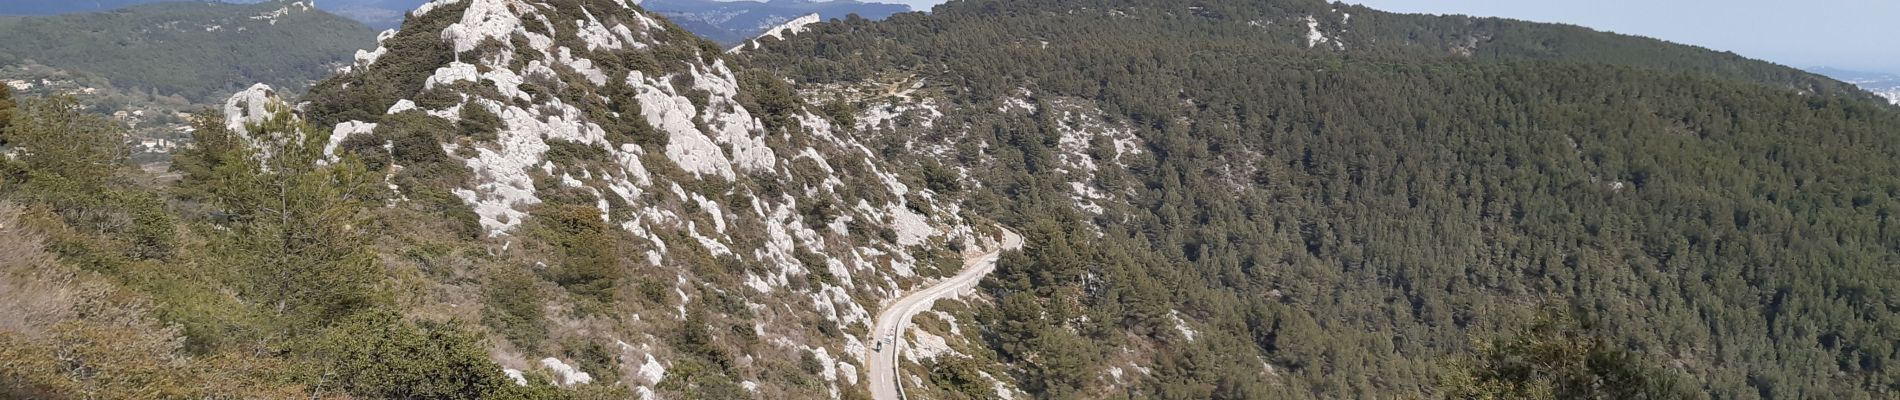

{"left": 0, "top": 0, "right": 1900, "bottom": 400}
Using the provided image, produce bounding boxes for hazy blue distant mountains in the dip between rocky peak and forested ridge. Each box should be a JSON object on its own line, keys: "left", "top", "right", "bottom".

{"left": 640, "top": 0, "right": 910, "bottom": 44}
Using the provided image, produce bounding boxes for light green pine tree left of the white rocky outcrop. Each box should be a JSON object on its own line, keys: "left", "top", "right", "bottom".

{"left": 179, "top": 106, "right": 380, "bottom": 324}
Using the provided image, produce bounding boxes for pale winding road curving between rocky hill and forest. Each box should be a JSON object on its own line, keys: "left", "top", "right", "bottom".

{"left": 866, "top": 231, "right": 1022, "bottom": 400}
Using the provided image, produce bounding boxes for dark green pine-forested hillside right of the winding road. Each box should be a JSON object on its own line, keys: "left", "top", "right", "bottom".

{"left": 743, "top": 0, "right": 1900, "bottom": 398}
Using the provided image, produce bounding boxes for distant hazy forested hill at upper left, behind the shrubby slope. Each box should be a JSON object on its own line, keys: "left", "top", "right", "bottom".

{"left": 0, "top": 0, "right": 376, "bottom": 102}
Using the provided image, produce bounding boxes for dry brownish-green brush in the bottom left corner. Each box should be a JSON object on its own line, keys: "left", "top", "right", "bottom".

{"left": 0, "top": 203, "right": 298, "bottom": 398}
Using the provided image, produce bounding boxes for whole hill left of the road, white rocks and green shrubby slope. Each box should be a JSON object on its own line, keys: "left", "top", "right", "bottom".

{"left": 0, "top": 0, "right": 1001, "bottom": 398}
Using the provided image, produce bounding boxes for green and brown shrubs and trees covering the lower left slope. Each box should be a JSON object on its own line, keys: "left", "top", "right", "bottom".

{"left": 0, "top": 92, "right": 574, "bottom": 398}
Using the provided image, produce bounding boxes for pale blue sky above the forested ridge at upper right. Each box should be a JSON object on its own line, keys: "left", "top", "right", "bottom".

{"left": 876, "top": 0, "right": 1900, "bottom": 74}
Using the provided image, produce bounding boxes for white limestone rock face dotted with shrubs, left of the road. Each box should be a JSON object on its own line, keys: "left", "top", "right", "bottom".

{"left": 241, "top": 0, "right": 986, "bottom": 396}
